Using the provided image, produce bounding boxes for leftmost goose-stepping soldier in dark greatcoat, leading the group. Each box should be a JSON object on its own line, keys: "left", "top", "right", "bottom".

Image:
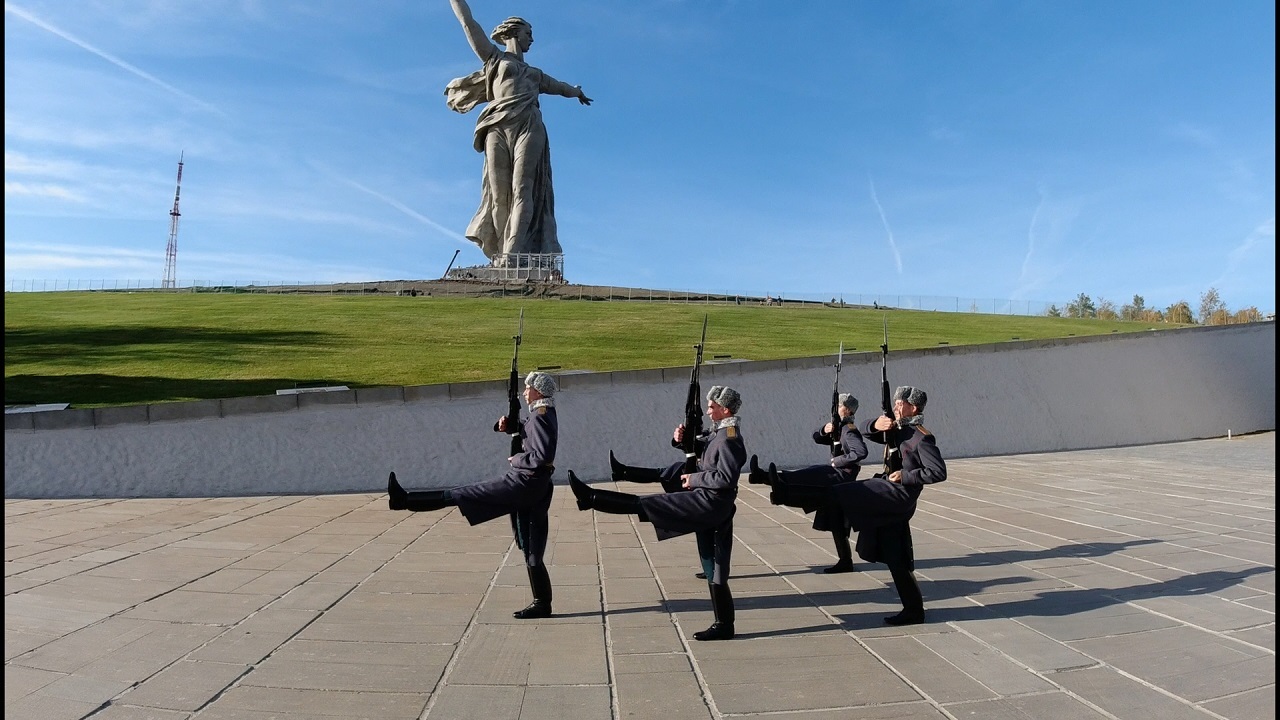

{"left": 387, "top": 373, "right": 558, "bottom": 620}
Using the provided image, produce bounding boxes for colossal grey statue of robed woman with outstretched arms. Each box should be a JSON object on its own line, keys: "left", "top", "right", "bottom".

{"left": 444, "top": 0, "right": 591, "bottom": 264}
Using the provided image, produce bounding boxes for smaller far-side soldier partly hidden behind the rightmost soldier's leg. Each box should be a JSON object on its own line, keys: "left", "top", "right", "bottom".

{"left": 748, "top": 392, "right": 867, "bottom": 573}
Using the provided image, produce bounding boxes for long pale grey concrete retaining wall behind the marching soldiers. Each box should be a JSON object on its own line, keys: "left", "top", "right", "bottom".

{"left": 4, "top": 323, "right": 1276, "bottom": 497}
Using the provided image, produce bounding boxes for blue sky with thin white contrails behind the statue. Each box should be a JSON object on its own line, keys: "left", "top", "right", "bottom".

{"left": 5, "top": 0, "right": 1275, "bottom": 311}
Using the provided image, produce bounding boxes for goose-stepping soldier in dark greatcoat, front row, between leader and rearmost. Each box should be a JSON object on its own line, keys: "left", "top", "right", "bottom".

{"left": 568, "top": 386, "right": 746, "bottom": 641}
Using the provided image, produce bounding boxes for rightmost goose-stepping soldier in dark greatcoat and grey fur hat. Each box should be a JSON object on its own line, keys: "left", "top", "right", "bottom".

{"left": 769, "top": 386, "right": 947, "bottom": 625}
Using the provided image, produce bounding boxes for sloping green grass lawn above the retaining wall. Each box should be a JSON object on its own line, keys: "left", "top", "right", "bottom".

{"left": 4, "top": 292, "right": 1169, "bottom": 407}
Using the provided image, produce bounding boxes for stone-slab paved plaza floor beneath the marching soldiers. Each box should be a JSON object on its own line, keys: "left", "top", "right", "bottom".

{"left": 5, "top": 433, "right": 1275, "bottom": 720}
